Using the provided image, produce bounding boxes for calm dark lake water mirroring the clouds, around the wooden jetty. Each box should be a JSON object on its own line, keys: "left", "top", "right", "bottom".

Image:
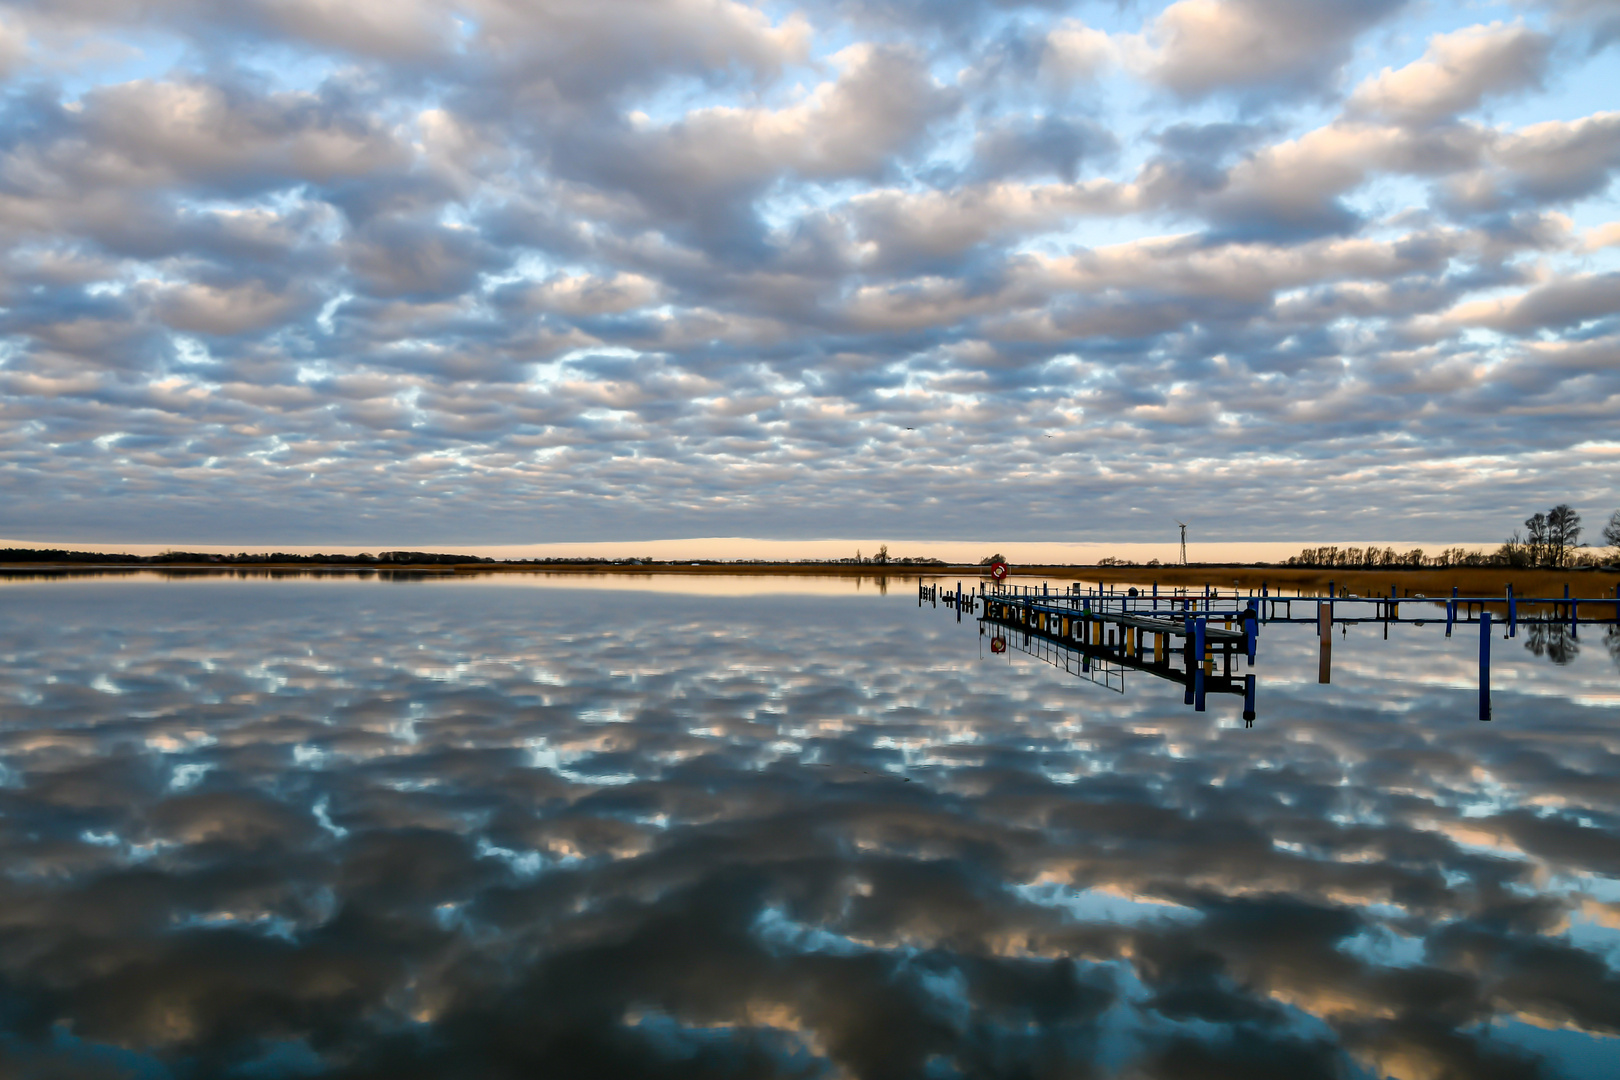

{"left": 0, "top": 580, "right": 1620, "bottom": 1080}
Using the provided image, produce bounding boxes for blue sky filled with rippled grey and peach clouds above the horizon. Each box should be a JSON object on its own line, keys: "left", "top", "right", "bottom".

{"left": 0, "top": 0, "right": 1620, "bottom": 547}
